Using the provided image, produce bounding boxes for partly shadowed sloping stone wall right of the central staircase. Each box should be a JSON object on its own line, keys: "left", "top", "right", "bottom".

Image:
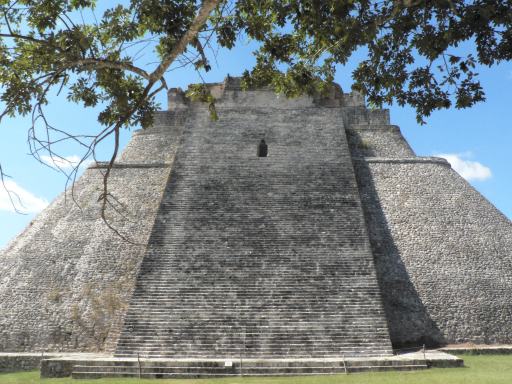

{"left": 355, "top": 157, "right": 512, "bottom": 346}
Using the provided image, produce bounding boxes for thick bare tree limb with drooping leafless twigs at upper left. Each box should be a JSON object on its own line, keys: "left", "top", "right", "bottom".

{"left": 0, "top": 0, "right": 223, "bottom": 244}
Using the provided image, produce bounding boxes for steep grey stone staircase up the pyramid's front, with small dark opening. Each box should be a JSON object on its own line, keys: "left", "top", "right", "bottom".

{"left": 111, "top": 108, "right": 391, "bottom": 364}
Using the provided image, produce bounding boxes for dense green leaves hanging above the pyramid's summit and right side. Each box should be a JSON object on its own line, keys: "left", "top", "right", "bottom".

{"left": 218, "top": 0, "right": 512, "bottom": 122}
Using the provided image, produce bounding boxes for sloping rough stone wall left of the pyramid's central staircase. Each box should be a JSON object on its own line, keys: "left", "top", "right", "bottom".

{"left": 0, "top": 110, "right": 183, "bottom": 351}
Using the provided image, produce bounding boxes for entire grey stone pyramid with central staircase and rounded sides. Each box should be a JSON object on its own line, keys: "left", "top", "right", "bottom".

{"left": 0, "top": 78, "right": 512, "bottom": 358}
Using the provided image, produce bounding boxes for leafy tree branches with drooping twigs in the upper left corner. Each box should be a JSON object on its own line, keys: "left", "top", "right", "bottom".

{"left": 0, "top": 0, "right": 221, "bottom": 230}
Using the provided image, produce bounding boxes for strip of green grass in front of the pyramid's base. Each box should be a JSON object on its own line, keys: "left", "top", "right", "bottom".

{"left": 0, "top": 355, "right": 512, "bottom": 384}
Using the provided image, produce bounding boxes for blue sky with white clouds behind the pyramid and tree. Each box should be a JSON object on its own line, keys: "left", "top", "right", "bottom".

{"left": 0, "top": 14, "right": 512, "bottom": 248}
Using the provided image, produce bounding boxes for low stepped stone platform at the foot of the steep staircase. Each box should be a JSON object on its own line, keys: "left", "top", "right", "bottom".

{"left": 37, "top": 351, "right": 464, "bottom": 379}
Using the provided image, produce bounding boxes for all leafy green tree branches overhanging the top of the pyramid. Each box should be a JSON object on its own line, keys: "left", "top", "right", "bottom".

{"left": 0, "top": 0, "right": 512, "bottom": 225}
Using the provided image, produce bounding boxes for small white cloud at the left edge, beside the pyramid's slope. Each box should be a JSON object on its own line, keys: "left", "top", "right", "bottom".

{"left": 0, "top": 180, "right": 48, "bottom": 213}
